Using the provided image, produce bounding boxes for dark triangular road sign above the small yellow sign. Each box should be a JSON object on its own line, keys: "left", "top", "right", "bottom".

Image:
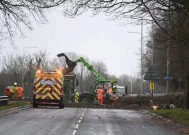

{"left": 144, "top": 66, "right": 160, "bottom": 80}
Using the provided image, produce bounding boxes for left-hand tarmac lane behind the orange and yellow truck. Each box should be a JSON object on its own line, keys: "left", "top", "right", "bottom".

{"left": 0, "top": 108, "right": 84, "bottom": 135}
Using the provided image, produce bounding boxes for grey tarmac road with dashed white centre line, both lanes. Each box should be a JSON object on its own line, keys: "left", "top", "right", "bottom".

{"left": 0, "top": 108, "right": 177, "bottom": 135}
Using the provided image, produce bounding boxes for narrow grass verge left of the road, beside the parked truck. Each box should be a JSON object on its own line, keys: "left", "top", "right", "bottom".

{"left": 0, "top": 102, "right": 29, "bottom": 111}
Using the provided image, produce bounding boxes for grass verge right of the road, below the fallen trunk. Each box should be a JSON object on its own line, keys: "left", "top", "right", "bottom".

{"left": 150, "top": 108, "right": 189, "bottom": 126}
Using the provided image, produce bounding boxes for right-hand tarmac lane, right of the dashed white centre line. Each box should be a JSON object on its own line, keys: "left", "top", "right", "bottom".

{"left": 74, "top": 109, "right": 178, "bottom": 135}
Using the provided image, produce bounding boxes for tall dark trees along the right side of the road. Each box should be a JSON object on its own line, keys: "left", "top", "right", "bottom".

{"left": 143, "top": 0, "right": 189, "bottom": 107}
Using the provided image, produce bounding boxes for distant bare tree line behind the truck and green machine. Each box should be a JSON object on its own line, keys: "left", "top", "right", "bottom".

{"left": 0, "top": 50, "right": 139, "bottom": 96}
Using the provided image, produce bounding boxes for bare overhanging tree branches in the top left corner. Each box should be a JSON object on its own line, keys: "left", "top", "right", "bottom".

{"left": 0, "top": 0, "right": 65, "bottom": 40}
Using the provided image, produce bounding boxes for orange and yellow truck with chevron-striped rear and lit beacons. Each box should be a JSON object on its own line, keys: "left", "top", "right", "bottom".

{"left": 33, "top": 69, "right": 64, "bottom": 108}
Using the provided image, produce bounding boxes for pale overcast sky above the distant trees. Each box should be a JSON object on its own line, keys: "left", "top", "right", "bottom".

{"left": 2, "top": 8, "right": 147, "bottom": 76}
